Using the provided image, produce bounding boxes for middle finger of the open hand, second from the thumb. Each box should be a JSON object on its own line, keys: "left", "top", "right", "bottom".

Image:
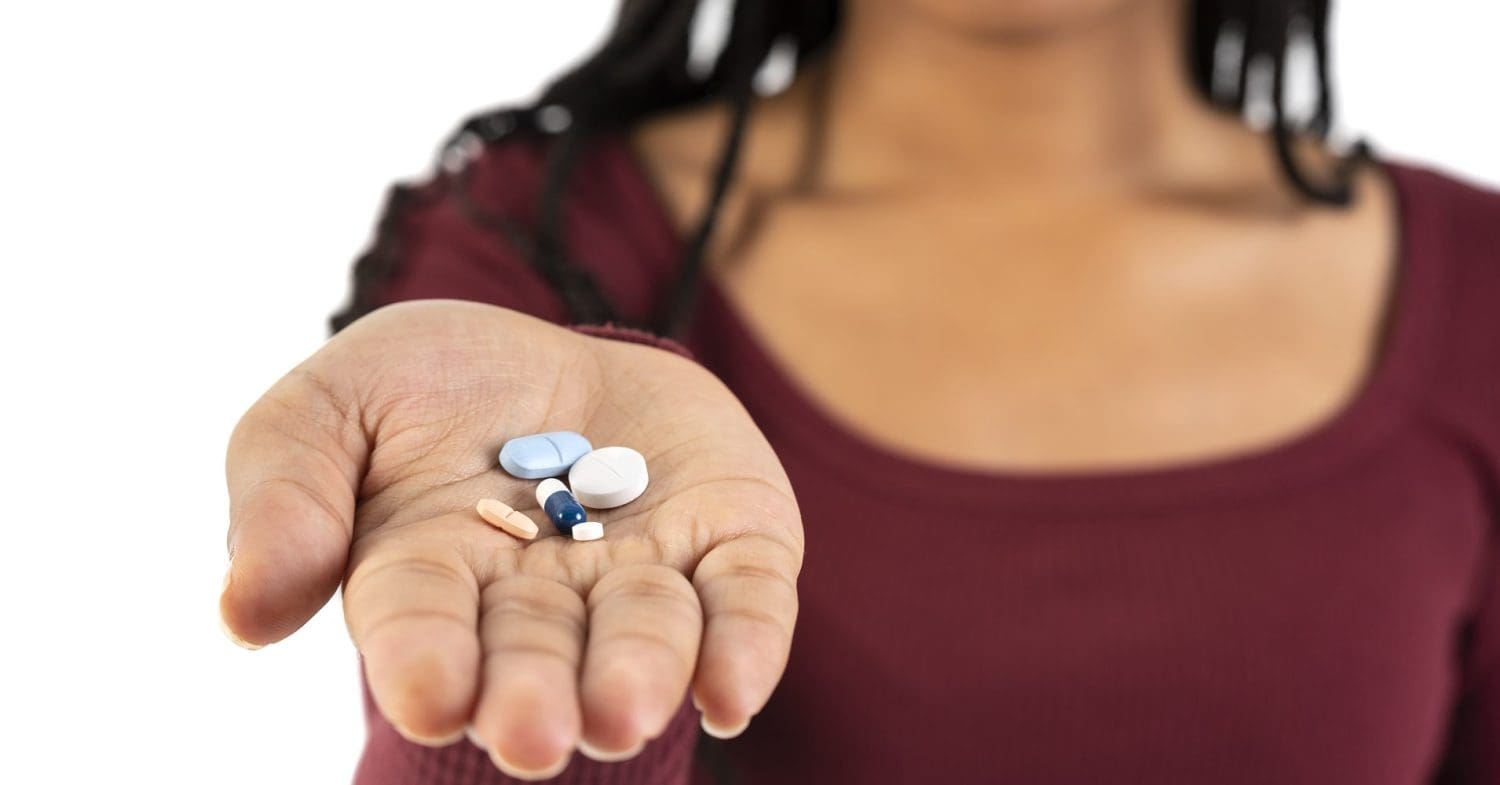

{"left": 474, "top": 576, "right": 587, "bottom": 779}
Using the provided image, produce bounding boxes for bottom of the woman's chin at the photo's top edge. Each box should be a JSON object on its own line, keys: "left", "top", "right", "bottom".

{"left": 882, "top": 0, "right": 1145, "bottom": 36}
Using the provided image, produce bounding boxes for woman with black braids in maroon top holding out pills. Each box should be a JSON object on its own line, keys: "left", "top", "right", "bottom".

{"left": 222, "top": 0, "right": 1500, "bottom": 785}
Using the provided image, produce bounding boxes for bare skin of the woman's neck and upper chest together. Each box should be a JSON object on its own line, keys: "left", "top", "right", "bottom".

{"left": 635, "top": 0, "right": 1395, "bottom": 471}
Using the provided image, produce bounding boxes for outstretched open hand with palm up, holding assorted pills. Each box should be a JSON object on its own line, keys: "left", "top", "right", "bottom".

{"left": 221, "top": 302, "right": 803, "bottom": 777}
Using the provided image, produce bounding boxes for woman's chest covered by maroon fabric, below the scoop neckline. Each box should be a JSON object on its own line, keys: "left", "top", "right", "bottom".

{"left": 720, "top": 423, "right": 1487, "bottom": 785}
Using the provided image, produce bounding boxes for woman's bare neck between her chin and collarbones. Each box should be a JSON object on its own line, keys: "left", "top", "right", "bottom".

{"left": 822, "top": 0, "right": 1245, "bottom": 191}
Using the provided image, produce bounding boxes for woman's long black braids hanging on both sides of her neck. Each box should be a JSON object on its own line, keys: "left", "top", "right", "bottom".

{"left": 333, "top": 0, "right": 1365, "bottom": 335}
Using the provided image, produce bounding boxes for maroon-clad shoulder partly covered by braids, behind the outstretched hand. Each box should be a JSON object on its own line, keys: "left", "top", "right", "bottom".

{"left": 336, "top": 110, "right": 675, "bottom": 324}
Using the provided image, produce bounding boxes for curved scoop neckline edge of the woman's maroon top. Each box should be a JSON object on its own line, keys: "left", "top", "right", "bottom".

{"left": 615, "top": 135, "right": 1439, "bottom": 512}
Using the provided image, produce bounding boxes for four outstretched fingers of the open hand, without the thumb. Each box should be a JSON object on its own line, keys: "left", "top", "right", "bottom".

{"left": 345, "top": 527, "right": 798, "bottom": 765}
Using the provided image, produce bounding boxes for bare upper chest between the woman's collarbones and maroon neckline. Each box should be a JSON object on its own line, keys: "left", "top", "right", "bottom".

{"left": 719, "top": 192, "right": 1394, "bottom": 468}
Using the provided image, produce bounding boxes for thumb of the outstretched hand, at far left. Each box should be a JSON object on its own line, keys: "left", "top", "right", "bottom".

{"left": 219, "top": 372, "right": 366, "bottom": 647}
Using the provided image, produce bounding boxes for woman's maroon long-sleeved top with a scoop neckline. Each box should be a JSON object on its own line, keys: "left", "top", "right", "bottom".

{"left": 345, "top": 138, "right": 1500, "bottom": 785}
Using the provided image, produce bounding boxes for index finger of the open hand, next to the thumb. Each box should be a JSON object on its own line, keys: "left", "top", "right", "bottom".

{"left": 344, "top": 533, "right": 480, "bottom": 744}
